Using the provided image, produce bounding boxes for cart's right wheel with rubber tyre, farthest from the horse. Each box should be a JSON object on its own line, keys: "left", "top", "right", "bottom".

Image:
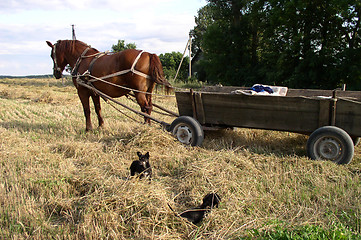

{"left": 307, "top": 126, "right": 354, "bottom": 164}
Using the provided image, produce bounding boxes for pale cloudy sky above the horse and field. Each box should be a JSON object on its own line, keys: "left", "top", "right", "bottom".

{"left": 0, "top": 0, "right": 206, "bottom": 76}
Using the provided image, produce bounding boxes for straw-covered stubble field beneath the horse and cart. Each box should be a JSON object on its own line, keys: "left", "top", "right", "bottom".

{"left": 0, "top": 78, "right": 361, "bottom": 239}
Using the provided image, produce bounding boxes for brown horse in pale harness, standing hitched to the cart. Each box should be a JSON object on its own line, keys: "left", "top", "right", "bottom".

{"left": 46, "top": 40, "right": 170, "bottom": 131}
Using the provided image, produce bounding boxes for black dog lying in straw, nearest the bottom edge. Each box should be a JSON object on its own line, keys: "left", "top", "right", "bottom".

{"left": 180, "top": 193, "right": 221, "bottom": 224}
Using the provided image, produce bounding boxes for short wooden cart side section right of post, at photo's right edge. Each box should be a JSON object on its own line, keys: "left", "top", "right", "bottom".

{"left": 336, "top": 99, "right": 361, "bottom": 137}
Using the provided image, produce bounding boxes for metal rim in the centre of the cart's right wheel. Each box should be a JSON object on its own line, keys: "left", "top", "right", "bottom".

{"left": 315, "top": 137, "right": 344, "bottom": 161}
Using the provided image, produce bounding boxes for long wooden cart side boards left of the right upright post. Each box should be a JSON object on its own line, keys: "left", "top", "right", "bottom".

{"left": 176, "top": 92, "right": 329, "bottom": 133}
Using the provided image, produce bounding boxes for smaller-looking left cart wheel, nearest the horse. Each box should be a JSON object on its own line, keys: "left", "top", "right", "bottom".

{"left": 169, "top": 116, "right": 204, "bottom": 146}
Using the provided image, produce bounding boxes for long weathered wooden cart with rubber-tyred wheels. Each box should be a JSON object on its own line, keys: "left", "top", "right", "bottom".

{"left": 168, "top": 87, "right": 361, "bottom": 164}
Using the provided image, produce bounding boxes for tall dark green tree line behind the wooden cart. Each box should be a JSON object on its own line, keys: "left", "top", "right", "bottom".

{"left": 190, "top": 0, "right": 361, "bottom": 90}
